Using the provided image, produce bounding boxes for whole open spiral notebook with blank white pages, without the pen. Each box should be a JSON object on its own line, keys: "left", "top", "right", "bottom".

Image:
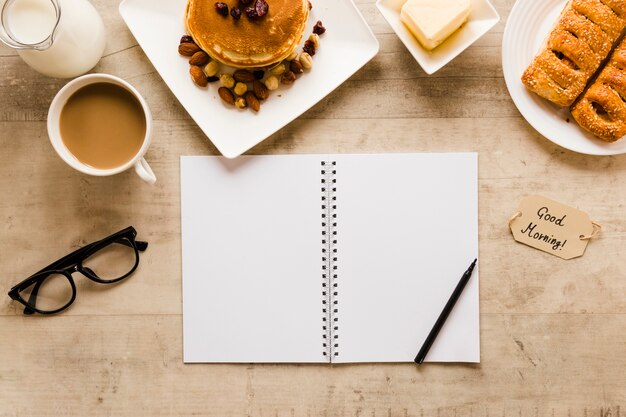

{"left": 181, "top": 153, "right": 480, "bottom": 363}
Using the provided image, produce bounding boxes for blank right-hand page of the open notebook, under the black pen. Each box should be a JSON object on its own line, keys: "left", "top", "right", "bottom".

{"left": 332, "top": 153, "right": 480, "bottom": 362}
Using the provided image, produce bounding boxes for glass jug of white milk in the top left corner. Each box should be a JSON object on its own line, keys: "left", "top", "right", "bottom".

{"left": 0, "top": 0, "right": 105, "bottom": 78}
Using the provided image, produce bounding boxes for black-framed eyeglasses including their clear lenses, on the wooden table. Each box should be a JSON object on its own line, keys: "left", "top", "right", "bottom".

{"left": 9, "top": 226, "right": 148, "bottom": 314}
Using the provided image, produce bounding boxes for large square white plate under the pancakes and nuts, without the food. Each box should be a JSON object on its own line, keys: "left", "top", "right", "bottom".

{"left": 119, "top": 0, "right": 378, "bottom": 158}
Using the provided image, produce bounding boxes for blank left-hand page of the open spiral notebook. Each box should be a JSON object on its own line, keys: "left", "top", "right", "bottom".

{"left": 181, "top": 155, "right": 327, "bottom": 362}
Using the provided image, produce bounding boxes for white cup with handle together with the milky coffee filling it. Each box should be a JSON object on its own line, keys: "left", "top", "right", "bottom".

{"left": 48, "top": 74, "right": 156, "bottom": 183}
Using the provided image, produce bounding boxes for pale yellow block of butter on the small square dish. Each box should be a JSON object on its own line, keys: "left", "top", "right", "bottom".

{"left": 400, "top": 0, "right": 471, "bottom": 51}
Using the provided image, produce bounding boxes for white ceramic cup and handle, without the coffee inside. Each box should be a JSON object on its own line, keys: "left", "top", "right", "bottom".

{"left": 48, "top": 74, "right": 156, "bottom": 184}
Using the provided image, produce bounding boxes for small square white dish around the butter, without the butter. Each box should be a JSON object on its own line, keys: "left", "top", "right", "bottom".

{"left": 376, "top": 0, "right": 500, "bottom": 74}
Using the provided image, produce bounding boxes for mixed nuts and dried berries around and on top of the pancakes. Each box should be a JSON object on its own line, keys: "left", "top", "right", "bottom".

{"left": 178, "top": 19, "right": 326, "bottom": 112}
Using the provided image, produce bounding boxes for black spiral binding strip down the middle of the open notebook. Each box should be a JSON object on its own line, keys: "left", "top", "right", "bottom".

{"left": 321, "top": 161, "right": 339, "bottom": 362}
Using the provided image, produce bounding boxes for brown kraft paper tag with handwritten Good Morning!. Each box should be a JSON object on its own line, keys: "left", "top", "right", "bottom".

{"left": 509, "top": 195, "right": 601, "bottom": 259}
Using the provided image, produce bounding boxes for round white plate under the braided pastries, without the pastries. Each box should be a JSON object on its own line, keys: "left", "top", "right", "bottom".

{"left": 502, "top": 0, "right": 626, "bottom": 155}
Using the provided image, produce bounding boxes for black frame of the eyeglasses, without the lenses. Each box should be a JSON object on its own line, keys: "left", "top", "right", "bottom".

{"left": 9, "top": 226, "right": 148, "bottom": 314}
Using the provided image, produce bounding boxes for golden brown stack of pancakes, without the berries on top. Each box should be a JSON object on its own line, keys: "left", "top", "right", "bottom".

{"left": 185, "top": 0, "right": 309, "bottom": 68}
